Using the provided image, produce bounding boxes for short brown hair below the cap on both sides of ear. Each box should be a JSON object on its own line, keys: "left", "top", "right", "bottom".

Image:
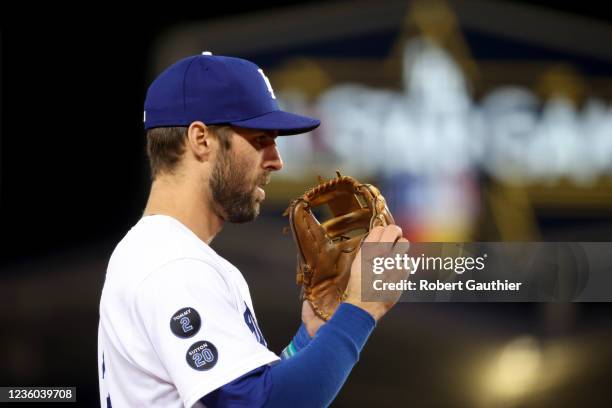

{"left": 147, "top": 125, "right": 232, "bottom": 179}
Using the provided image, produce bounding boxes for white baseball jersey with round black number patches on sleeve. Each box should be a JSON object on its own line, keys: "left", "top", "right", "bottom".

{"left": 98, "top": 215, "right": 278, "bottom": 408}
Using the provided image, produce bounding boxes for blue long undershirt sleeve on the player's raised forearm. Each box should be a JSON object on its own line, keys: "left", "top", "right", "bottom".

{"left": 202, "top": 303, "right": 375, "bottom": 408}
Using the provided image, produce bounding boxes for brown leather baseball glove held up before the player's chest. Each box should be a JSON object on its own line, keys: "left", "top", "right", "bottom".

{"left": 284, "top": 172, "right": 395, "bottom": 320}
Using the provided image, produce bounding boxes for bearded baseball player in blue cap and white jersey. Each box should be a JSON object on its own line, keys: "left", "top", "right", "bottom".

{"left": 98, "top": 53, "right": 403, "bottom": 408}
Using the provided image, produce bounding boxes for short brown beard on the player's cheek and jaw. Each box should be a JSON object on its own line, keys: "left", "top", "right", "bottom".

{"left": 209, "top": 150, "right": 269, "bottom": 223}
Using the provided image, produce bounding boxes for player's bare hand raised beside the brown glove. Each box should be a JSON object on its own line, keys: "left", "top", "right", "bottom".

{"left": 345, "top": 225, "right": 408, "bottom": 321}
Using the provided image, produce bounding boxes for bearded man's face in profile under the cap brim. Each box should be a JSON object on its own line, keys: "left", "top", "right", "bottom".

{"left": 210, "top": 127, "right": 283, "bottom": 223}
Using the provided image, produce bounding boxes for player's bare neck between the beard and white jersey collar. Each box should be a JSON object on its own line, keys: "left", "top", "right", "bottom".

{"left": 143, "top": 172, "right": 224, "bottom": 244}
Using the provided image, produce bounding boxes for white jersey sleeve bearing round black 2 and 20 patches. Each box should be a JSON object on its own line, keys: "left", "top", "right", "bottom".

{"left": 134, "top": 259, "right": 277, "bottom": 406}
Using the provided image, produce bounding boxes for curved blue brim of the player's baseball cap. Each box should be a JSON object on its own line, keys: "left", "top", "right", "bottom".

{"left": 230, "top": 110, "right": 321, "bottom": 136}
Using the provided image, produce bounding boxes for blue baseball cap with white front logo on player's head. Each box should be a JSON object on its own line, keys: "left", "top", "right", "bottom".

{"left": 144, "top": 52, "right": 321, "bottom": 135}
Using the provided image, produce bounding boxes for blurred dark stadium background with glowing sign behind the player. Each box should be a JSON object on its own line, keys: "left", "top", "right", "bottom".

{"left": 0, "top": 0, "right": 612, "bottom": 407}
